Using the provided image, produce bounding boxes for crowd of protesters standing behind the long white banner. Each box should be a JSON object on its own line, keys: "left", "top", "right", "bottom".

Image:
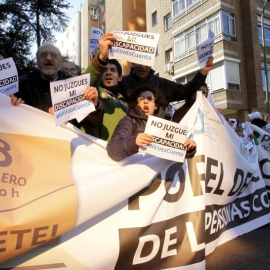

{"left": 0, "top": 33, "right": 270, "bottom": 160}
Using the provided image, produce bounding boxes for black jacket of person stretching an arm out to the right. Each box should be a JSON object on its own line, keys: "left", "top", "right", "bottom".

{"left": 120, "top": 69, "right": 206, "bottom": 106}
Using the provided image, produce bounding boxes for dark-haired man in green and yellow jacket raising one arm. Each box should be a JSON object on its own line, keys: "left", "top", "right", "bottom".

{"left": 85, "top": 33, "right": 128, "bottom": 141}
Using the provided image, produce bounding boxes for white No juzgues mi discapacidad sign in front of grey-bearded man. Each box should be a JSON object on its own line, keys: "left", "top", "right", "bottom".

{"left": 50, "top": 74, "right": 95, "bottom": 125}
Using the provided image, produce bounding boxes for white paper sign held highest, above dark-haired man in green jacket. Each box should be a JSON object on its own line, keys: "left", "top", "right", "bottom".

{"left": 109, "top": 31, "right": 159, "bottom": 66}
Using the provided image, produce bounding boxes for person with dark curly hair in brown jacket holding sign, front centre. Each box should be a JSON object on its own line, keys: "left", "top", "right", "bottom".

{"left": 107, "top": 84, "right": 196, "bottom": 161}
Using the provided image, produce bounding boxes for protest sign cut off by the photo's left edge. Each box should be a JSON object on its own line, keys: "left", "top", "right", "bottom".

{"left": 0, "top": 58, "right": 19, "bottom": 96}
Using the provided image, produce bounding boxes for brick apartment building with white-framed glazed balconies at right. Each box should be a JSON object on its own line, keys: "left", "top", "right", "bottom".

{"left": 146, "top": 0, "right": 270, "bottom": 121}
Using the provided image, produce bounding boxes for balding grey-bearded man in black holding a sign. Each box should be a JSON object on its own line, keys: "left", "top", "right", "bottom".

{"left": 11, "top": 43, "right": 103, "bottom": 128}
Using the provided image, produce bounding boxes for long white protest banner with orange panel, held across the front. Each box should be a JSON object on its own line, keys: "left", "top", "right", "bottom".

{"left": 0, "top": 92, "right": 270, "bottom": 270}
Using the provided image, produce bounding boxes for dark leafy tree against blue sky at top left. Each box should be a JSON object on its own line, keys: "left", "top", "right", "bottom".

{"left": 0, "top": 0, "right": 71, "bottom": 74}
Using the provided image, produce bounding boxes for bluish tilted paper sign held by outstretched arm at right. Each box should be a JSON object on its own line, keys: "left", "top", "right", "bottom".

{"left": 196, "top": 30, "right": 215, "bottom": 68}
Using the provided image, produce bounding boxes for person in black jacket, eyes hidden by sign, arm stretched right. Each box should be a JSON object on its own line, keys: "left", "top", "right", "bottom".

{"left": 121, "top": 57, "right": 213, "bottom": 107}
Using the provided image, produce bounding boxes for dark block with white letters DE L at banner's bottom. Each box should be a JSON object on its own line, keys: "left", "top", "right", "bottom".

{"left": 115, "top": 211, "right": 205, "bottom": 270}
